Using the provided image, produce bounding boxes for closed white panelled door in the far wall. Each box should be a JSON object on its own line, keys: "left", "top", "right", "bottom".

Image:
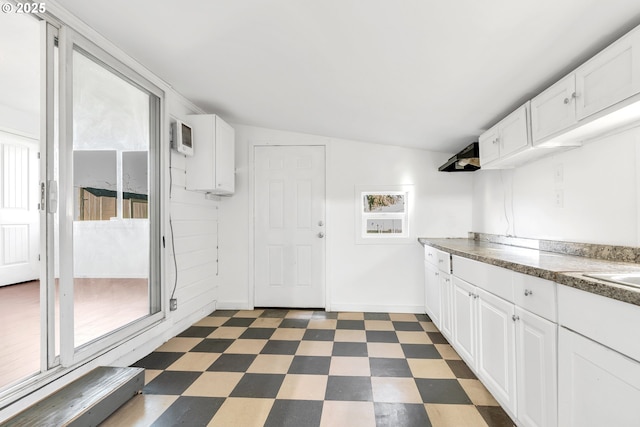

{"left": 254, "top": 146, "right": 325, "bottom": 307}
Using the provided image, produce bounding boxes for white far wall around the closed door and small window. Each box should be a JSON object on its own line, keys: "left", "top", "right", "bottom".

{"left": 218, "top": 125, "right": 472, "bottom": 312}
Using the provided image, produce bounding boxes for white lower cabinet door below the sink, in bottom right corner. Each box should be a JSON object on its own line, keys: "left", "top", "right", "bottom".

{"left": 558, "top": 328, "right": 640, "bottom": 427}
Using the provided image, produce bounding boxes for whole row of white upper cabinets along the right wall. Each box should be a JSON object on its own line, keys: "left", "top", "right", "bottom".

{"left": 479, "top": 21, "right": 640, "bottom": 169}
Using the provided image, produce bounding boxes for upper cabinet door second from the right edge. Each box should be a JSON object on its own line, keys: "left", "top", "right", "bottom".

{"left": 531, "top": 74, "right": 576, "bottom": 145}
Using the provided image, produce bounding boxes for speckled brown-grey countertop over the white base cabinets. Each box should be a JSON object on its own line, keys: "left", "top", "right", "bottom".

{"left": 418, "top": 237, "right": 640, "bottom": 306}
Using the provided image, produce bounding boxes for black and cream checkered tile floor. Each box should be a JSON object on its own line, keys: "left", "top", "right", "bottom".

{"left": 103, "top": 309, "right": 513, "bottom": 427}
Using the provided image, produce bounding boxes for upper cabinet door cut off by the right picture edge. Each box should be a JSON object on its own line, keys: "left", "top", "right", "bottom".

{"left": 576, "top": 30, "right": 640, "bottom": 120}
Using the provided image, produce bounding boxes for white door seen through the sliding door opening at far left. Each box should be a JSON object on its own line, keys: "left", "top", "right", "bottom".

{"left": 0, "top": 132, "right": 40, "bottom": 286}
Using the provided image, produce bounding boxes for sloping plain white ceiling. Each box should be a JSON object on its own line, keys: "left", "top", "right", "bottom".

{"left": 47, "top": 0, "right": 640, "bottom": 152}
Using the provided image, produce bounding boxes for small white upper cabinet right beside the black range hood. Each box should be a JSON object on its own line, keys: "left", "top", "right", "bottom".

{"left": 479, "top": 102, "right": 531, "bottom": 169}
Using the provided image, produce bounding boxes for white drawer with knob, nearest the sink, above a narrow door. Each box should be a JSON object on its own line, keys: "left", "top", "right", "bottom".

{"left": 513, "top": 272, "right": 558, "bottom": 322}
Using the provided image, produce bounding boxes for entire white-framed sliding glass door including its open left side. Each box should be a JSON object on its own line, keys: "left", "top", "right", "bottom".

{"left": 0, "top": 14, "right": 164, "bottom": 404}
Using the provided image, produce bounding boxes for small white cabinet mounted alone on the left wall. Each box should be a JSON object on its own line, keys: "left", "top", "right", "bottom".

{"left": 186, "top": 114, "right": 235, "bottom": 195}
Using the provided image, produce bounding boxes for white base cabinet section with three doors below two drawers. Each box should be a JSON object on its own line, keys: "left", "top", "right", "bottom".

{"left": 450, "top": 257, "right": 556, "bottom": 427}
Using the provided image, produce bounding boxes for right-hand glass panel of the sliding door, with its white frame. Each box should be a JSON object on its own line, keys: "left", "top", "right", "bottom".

{"left": 60, "top": 29, "right": 162, "bottom": 365}
